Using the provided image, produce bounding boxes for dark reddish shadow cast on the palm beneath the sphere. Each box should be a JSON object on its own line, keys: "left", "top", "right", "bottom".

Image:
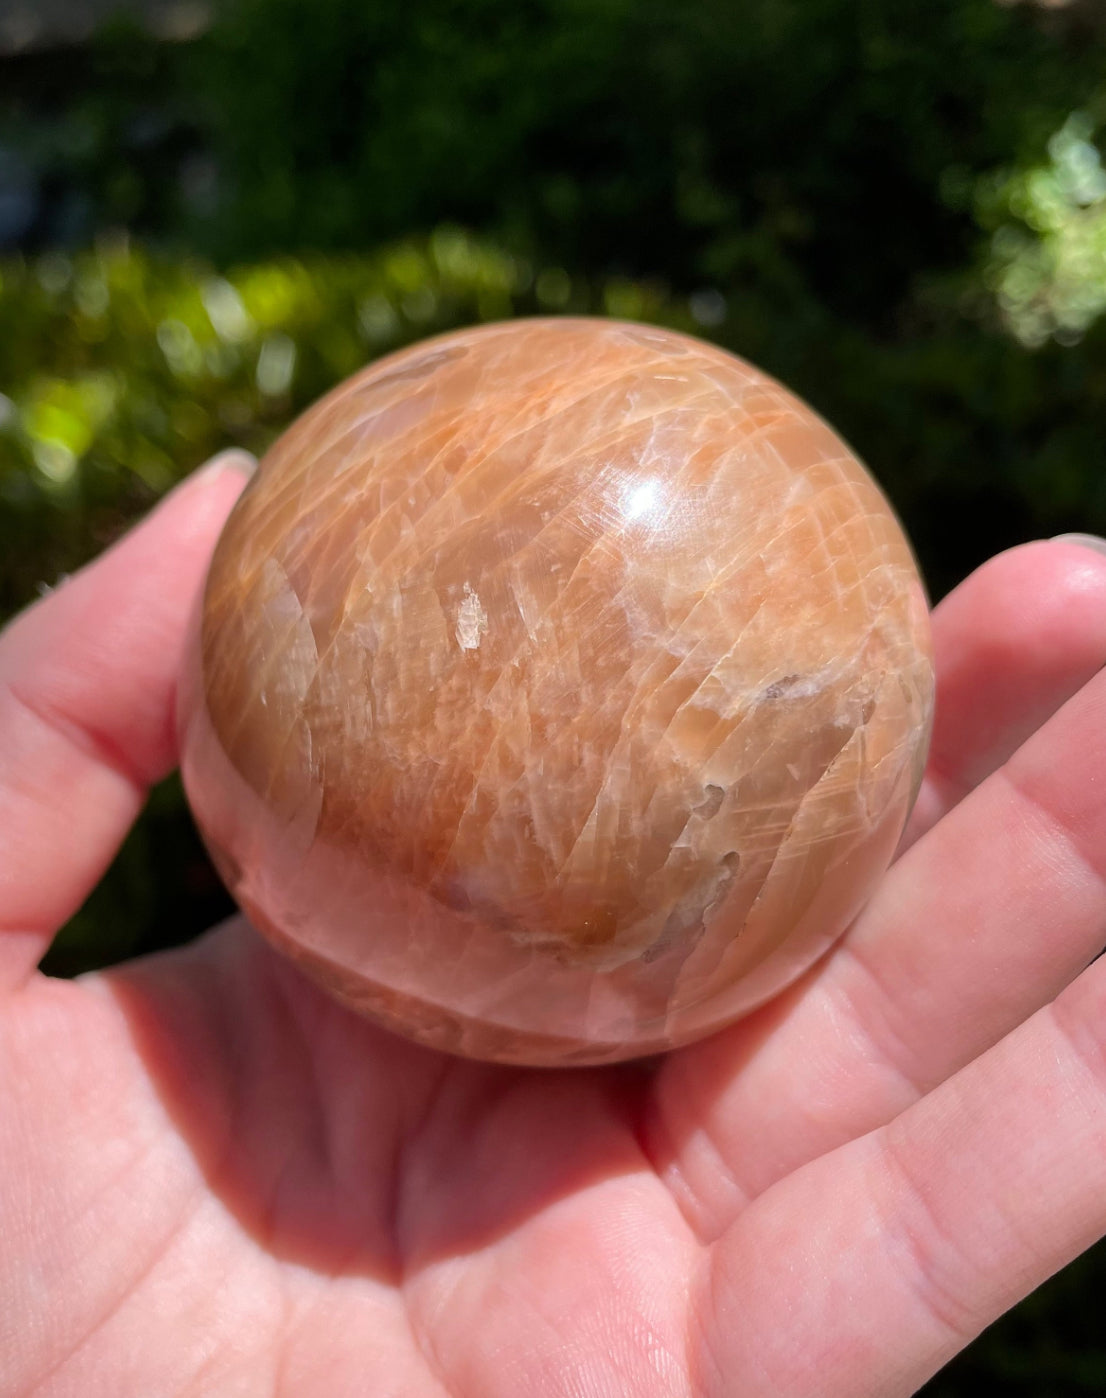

{"left": 112, "top": 920, "right": 665, "bottom": 1282}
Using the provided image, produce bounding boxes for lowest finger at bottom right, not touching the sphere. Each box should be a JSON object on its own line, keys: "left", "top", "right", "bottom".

{"left": 699, "top": 962, "right": 1106, "bottom": 1398}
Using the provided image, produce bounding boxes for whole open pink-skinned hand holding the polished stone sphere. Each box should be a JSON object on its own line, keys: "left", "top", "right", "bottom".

{"left": 0, "top": 459, "right": 1106, "bottom": 1398}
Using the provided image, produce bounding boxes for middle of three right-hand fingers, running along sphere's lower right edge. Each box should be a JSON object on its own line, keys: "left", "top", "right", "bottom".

{"left": 657, "top": 654, "right": 1106, "bottom": 1236}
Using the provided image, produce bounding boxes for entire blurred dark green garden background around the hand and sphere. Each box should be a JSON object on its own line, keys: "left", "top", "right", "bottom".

{"left": 0, "top": 0, "right": 1106, "bottom": 1398}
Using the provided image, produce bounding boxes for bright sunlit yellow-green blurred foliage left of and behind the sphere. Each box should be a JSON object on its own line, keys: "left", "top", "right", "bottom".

{"left": 0, "top": 229, "right": 654, "bottom": 612}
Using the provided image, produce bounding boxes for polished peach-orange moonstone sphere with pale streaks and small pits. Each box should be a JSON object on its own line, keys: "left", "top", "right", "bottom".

{"left": 180, "top": 320, "right": 933, "bottom": 1064}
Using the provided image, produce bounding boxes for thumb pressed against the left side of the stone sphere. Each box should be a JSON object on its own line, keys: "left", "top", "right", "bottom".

{"left": 0, "top": 453, "right": 252, "bottom": 990}
